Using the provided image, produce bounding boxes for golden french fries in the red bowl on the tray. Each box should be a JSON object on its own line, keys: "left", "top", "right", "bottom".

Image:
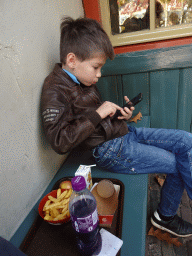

{"left": 43, "top": 188, "right": 73, "bottom": 221}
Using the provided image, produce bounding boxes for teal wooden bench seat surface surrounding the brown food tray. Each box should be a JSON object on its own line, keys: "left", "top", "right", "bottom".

{"left": 19, "top": 117, "right": 149, "bottom": 256}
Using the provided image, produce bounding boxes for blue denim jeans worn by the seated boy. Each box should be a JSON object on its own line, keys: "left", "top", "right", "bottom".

{"left": 93, "top": 126, "right": 192, "bottom": 216}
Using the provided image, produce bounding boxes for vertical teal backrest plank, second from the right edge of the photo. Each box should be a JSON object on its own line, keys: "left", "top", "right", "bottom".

{"left": 150, "top": 70, "right": 179, "bottom": 129}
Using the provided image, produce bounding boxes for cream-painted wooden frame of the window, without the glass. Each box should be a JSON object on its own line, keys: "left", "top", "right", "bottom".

{"left": 99, "top": 0, "right": 192, "bottom": 47}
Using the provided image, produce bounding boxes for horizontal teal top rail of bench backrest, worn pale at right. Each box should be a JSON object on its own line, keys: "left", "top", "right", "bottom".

{"left": 102, "top": 45, "right": 192, "bottom": 76}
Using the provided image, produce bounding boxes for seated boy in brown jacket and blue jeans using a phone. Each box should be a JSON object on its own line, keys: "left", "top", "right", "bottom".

{"left": 41, "top": 17, "right": 192, "bottom": 237}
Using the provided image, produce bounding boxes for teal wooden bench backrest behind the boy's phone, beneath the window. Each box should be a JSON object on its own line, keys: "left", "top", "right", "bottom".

{"left": 98, "top": 45, "right": 192, "bottom": 132}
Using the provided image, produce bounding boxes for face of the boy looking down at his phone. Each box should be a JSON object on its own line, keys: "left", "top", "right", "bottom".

{"left": 73, "top": 54, "right": 106, "bottom": 86}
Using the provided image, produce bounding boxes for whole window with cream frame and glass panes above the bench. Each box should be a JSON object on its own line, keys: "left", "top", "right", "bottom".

{"left": 100, "top": 0, "right": 192, "bottom": 45}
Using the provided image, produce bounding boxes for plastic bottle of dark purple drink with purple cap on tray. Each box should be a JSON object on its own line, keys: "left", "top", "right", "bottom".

{"left": 69, "top": 176, "right": 102, "bottom": 256}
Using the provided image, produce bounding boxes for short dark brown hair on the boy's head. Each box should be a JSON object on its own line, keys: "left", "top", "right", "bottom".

{"left": 60, "top": 17, "right": 114, "bottom": 64}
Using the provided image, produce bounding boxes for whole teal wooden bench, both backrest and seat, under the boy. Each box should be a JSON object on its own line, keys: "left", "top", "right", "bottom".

{"left": 11, "top": 45, "right": 192, "bottom": 256}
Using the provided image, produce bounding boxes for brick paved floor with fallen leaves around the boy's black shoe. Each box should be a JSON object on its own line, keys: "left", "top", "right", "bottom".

{"left": 145, "top": 174, "right": 192, "bottom": 256}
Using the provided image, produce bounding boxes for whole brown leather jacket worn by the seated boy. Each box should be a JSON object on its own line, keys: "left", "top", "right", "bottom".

{"left": 41, "top": 64, "right": 128, "bottom": 154}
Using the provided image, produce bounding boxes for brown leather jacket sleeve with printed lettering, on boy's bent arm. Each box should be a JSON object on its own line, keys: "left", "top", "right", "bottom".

{"left": 41, "top": 87, "right": 101, "bottom": 154}
